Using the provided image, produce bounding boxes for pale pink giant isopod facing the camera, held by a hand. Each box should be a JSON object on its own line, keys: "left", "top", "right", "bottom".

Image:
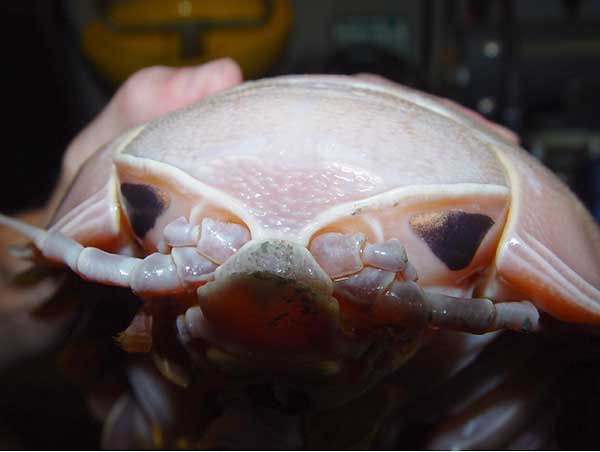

{"left": 0, "top": 76, "right": 600, "bottom": 400}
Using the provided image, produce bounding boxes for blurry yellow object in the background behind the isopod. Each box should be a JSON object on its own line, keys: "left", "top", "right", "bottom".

{"left": 82, "top": 0, "right": 292, "bottom": 83}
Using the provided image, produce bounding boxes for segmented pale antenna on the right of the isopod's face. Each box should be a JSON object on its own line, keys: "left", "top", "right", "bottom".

{"left": 310, "top": 233, "right": 540, "bottom": 334}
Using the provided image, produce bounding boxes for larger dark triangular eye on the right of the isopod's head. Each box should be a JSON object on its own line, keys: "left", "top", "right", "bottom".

{"left": 410, "top": 210, "right": 494, "bottom": 270}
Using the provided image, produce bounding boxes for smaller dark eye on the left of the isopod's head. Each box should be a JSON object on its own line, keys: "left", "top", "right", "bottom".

{"left": 121, "top": 183, "right": 169, "bottom": 238}
